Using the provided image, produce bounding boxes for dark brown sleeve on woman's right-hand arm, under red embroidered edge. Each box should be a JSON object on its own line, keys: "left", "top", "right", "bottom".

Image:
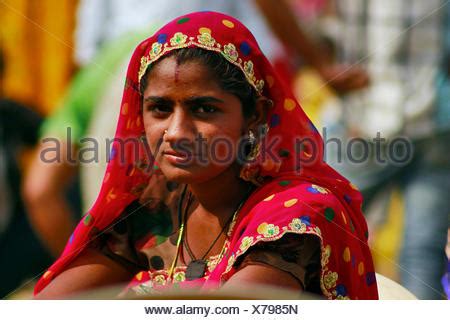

{"left": 235, "top": 234, "right": 321, "bottom": 294}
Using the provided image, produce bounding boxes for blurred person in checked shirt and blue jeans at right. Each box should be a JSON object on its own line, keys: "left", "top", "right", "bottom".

{"left": 325, "top": 0, "right": 450, "bottom": 299}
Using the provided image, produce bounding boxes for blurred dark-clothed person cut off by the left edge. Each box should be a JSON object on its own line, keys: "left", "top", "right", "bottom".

{"left": 0, "top": 50, "right": 51, "bottom": 298}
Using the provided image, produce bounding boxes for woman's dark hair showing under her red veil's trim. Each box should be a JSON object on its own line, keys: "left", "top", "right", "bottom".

{"left": 140, "top": 48, "right": 258, "bottom": 118}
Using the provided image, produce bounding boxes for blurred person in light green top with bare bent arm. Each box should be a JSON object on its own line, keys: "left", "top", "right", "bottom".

{"left": 24, "top": 33, "right": 143, "bottom": 256}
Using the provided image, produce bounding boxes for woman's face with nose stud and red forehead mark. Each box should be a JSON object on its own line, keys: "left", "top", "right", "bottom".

{"left": 143, "top": 57, "right": 246, "bottom": 184}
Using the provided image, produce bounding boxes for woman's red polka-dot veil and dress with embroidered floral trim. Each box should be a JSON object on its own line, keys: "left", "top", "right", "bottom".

{"left": 35, "top": 12, "right": 378, "bottom": 299}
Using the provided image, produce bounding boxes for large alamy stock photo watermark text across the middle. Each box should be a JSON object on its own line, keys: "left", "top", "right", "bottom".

{"left": 39, "top": 127, "right": 414, "bottom": 169}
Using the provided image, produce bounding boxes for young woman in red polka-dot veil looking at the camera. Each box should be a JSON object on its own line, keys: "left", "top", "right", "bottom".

{"left": 35, "top": 12, "right": 378, "bottom": 299}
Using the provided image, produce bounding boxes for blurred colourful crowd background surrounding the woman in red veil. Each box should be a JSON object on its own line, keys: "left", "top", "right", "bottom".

{"left": 0, "top": 0, "right": 450, "bottom": 299}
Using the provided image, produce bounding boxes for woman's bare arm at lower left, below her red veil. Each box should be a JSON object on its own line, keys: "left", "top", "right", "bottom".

{"left": 35, "top": 248, "right": 133, "bottom": 299}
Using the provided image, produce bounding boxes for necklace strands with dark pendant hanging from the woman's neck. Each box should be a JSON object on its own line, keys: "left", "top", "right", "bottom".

{"left": 168, "top": 185, "right": 252, "bottom": 280}
